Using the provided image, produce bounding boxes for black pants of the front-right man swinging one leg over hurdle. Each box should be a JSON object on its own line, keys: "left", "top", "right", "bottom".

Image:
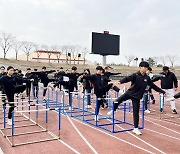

{"left": 114, "top": 92, "right": 140, "bottom": 128}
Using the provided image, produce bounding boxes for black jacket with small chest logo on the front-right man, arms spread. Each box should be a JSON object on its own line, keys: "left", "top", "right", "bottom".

{"left": 120, "top": 71, "right": 165, "bottom": 99}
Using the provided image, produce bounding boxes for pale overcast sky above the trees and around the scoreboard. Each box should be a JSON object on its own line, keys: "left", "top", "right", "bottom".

{"left": 0, "top": 0, "right": 180, "bottom": 63}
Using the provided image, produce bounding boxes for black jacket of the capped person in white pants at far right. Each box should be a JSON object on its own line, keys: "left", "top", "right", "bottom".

{"left": 152, "top": 72, "right": 178, "bottom": 89}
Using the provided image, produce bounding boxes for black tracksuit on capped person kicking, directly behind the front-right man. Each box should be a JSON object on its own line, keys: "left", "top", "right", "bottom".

{"left": 83, "top": 74, "right": 113, "bottom": 115}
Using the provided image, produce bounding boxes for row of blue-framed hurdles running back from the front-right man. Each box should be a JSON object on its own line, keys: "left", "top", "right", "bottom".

{"left": 45, "top": 86, "right": 144, "bottom": 133}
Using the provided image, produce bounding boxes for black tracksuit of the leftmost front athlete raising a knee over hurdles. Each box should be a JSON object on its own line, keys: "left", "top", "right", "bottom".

{"left": 0, "top": 75, "right": 30, "bottom": 119}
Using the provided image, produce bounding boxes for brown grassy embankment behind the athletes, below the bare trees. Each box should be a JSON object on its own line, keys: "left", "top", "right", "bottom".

{"left": 0, "top": 58, "right": 180, "bottom": 79}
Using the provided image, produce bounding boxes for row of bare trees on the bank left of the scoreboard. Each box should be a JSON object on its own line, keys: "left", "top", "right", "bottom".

{"left": 0, "top": 32, "right": 89, "bottom": 64}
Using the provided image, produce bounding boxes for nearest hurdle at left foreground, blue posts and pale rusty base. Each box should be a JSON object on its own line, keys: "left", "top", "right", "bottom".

{"left": 0, "top": 107, "right": 61, "bottom": 147}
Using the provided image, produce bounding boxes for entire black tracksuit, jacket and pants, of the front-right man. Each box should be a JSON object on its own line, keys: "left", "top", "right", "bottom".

{"left": 114, "top": 71, "right": 165, "bottom": 128}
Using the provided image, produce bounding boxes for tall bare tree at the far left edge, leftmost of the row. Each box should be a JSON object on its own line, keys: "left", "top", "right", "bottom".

{"left": 0, "top": 32, "right": 15, "bottom": 59}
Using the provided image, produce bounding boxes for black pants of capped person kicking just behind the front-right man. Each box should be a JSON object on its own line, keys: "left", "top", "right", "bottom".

{"left": 95, "top": 83, "right": 113, "bottom": 115}
